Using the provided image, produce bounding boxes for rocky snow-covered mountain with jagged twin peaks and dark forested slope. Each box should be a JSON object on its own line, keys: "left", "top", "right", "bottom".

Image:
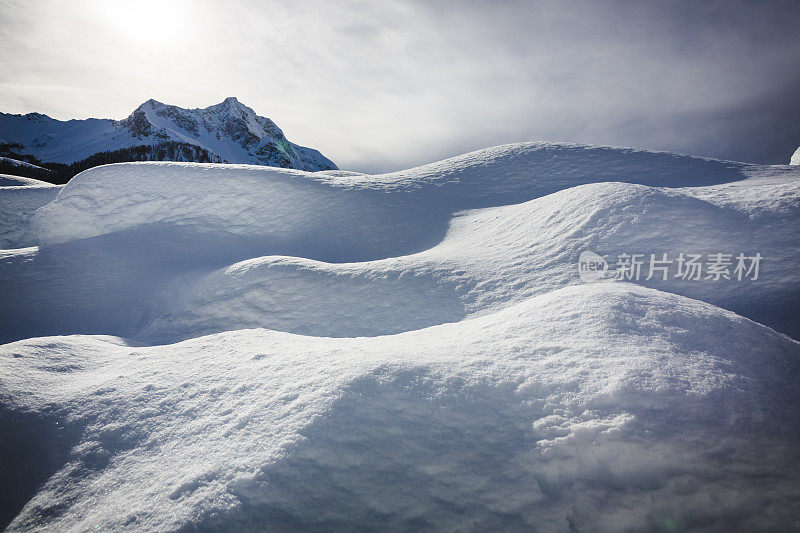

{"left": 0, "top": 97, "right": 337, "bottom": 172}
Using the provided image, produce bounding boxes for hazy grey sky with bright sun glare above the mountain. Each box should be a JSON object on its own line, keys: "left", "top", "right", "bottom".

{"left": 0, "top": 0, "right": 800, "bottom": 172}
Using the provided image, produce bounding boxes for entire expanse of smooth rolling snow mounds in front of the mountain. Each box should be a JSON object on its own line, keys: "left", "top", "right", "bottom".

{"left": 0, "top": 143, "right": 800, "bottom": 531}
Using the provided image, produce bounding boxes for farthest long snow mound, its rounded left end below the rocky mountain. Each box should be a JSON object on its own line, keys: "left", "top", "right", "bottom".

{"left": 38, "top": 143, "right": 750, "bottom": 247}
